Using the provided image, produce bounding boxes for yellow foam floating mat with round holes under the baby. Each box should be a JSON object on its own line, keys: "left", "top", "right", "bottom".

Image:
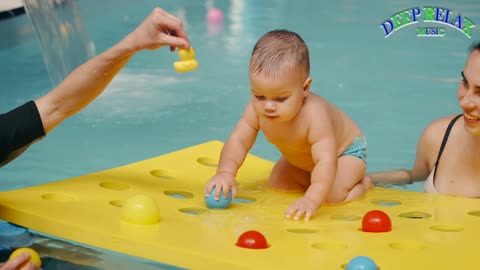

{"left": 0, "top": 141, "right": 480, "bottom": 270}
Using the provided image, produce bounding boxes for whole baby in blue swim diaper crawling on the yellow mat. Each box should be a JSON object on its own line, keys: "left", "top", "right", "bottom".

{"left": 205, "top": 30, "right": 371, "bottom": 220}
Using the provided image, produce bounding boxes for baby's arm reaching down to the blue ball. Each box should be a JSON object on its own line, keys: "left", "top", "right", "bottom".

{"left": 205, "top": 103, "right": 259, "bottom": 200}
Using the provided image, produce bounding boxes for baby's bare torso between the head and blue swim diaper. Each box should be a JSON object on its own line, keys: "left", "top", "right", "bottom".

{"left": 259, "top": 93, "right": 363, "bottom": 171}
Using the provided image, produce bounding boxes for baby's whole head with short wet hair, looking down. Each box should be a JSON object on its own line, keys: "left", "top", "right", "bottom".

{"left": 250, "top": 30, "right": 312, "bottom": 121}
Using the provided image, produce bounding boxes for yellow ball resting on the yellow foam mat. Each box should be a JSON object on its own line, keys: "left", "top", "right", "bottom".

{"left": 122, "top": 195, "right": 160, "bottom": 225}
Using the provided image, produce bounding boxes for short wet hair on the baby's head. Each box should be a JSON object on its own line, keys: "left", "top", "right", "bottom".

{"left": 250, "top": 29, "right": 310, "bottom": 78}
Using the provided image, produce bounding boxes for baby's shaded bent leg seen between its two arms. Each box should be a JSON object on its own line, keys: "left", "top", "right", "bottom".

{"left": 269, "top": 157, "right": 310, "bottom": 191}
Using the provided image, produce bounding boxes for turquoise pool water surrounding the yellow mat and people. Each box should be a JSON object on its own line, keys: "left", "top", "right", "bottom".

{"left": 0, "top": 0, "right": 480, "bottom": 266}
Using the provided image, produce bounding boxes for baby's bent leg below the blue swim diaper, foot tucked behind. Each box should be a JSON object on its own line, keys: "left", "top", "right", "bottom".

{"left": 327, "top": 156, "right": 372, "bottom": 203}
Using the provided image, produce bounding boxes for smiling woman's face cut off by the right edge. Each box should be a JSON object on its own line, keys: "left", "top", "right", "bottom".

{"left": 457, "top": 50, "right": 480, "bottom": 136}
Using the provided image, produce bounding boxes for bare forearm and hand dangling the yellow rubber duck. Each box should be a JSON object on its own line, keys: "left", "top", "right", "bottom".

{"left": 35, "top": 8, "right": 190, "bottom": 133}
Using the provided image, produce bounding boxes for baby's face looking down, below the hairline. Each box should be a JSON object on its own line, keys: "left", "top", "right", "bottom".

{"left": 250, "top": 68, "right": 311, "bottom": 122}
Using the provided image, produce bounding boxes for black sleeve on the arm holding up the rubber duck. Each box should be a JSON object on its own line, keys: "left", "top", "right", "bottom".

{"left": 0, "top": 101, "right": 45, "bottom": 167}
